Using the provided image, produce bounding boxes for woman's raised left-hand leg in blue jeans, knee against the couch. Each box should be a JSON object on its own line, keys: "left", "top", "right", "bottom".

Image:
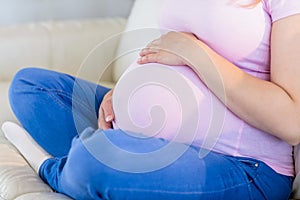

{"left": 9, "top": 68, "right": 109, "bottom": 156}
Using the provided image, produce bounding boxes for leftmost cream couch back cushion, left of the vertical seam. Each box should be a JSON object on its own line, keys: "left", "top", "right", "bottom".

{"left": 0, "top": 24, "right": 51, "bottom": 81}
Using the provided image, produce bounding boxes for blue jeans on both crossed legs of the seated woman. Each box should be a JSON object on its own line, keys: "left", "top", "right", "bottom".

{"left": 9, "top": 68, "right": 292, "bottom": 200}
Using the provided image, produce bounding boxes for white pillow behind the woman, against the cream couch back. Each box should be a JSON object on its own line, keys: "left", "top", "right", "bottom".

{"left": 113, "top": 0, "right": 165, "bottom": 82}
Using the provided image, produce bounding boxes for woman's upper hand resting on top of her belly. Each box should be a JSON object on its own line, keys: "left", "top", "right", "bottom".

{"left": 137, "top": 31, "right": 198, "bottom": 66}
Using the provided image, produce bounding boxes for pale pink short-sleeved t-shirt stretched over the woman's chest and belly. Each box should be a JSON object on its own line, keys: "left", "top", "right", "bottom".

{"left": 114, "top": 0, "right": 300, "bottom": 175}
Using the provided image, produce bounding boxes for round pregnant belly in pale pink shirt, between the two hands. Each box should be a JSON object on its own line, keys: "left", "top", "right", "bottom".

{"left": 113, "top": 63, "right": 225, "bottom": 145}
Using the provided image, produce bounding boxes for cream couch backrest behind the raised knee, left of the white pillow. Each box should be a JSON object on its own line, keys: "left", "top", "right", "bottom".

{"left": 0, "top": 18, "right": 127, "bottom": 81}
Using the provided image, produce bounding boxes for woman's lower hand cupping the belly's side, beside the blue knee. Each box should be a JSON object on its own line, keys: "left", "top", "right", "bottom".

{"left": 98, "top": 89, "right": 115, "bottom": 130}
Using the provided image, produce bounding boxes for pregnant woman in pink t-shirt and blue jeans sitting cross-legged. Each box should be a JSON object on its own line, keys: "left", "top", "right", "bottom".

{"left": 4, "top": 0, "right": 300, "bottom": 200}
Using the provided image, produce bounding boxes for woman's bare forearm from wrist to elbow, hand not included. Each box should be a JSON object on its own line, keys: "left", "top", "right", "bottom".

{"left": 183, "top": 39, "right": 300, "bottom": 144}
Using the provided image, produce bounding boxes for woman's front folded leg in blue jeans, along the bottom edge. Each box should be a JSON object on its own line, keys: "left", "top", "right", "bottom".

{"left": 40, "top": 128, "right": 291, "bottom": 200}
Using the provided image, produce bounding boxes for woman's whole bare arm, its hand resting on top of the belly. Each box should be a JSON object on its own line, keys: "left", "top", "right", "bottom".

{"left": 138, "top": 23, "right": 300, "bottom": 144}
